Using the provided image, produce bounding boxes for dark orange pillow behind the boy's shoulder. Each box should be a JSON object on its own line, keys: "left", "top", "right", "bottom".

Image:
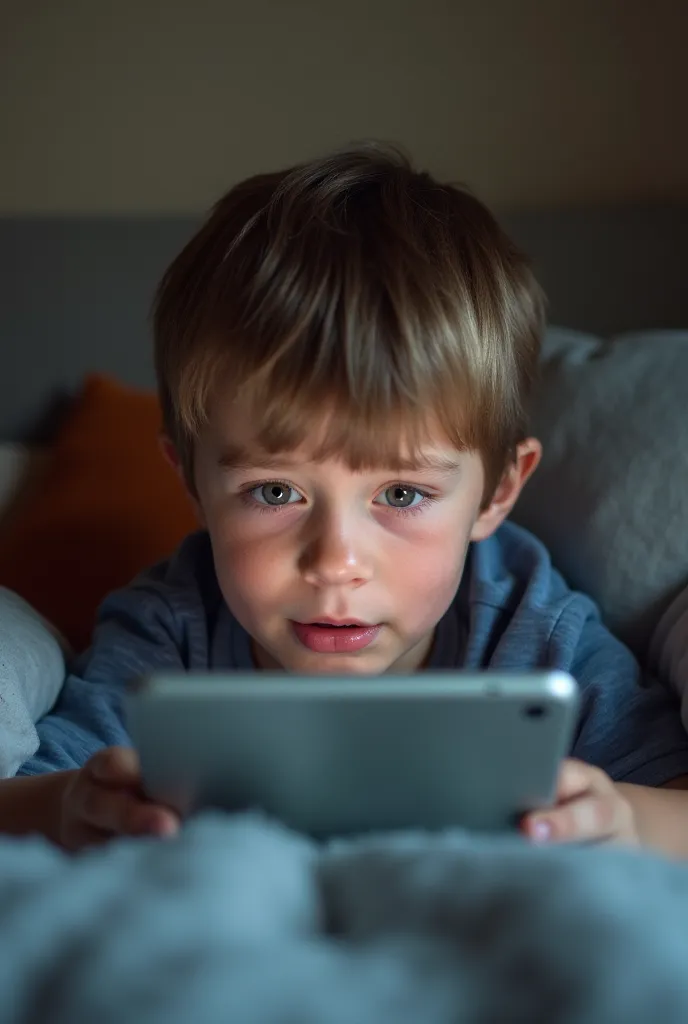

{"left": 0, "top": 376, "right": 198, "bottom": 650}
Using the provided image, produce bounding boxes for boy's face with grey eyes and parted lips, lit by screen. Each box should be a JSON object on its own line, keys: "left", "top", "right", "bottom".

{"left": 172, "top": 397, "right": 539, "bottom": 675}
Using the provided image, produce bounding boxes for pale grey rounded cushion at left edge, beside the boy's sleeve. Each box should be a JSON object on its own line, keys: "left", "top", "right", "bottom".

{"left": 0, "top": 587, "right": 66, "bottom": 778}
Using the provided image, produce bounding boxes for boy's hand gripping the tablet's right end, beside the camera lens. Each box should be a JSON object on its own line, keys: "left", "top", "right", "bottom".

{"left": 522, "top": 759, "right": 640, "bottom": 846}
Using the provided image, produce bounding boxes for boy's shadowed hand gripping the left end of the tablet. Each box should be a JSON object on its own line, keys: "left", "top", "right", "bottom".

{"left": 59, "top": 746, "right": 179, "bottom": 850}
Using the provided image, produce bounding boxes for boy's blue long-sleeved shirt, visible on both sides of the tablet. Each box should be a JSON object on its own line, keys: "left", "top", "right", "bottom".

{"left": 18, "top": 523, "right": 688, "bottom": 785}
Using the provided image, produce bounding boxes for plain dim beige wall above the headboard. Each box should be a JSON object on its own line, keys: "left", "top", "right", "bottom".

{"left": 0, "top": 0, "right": 688, "bottom": 213}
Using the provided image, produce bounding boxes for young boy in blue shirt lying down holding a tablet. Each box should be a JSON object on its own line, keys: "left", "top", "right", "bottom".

{"left": 0, "top": 140, "right": 688, "bottom": 856}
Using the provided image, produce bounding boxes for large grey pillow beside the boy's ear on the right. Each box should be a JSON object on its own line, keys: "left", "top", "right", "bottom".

{"left": 513, "top": 329, "right": 688, "bottom": 657}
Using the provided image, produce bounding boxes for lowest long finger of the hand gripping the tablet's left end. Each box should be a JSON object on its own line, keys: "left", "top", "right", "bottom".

{"left": 74, "top": 782, "right": 179, "bottom": 836}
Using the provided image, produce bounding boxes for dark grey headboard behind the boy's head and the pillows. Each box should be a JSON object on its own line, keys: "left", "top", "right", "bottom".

{"left": 0, "top": 206, "right": 688, "bottom": 440}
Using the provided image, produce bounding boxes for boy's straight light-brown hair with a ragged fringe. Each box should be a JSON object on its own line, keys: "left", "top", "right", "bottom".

{"left": 154, "top": 144, "right": 544, "bottom": 498}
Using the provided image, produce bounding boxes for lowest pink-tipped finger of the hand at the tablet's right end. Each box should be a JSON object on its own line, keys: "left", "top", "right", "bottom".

{"left": 525, "top": 793, "right": 624, "bottom": 843}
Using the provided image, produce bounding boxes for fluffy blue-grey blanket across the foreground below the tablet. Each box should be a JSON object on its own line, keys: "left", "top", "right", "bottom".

{"left": 0, "top": 816, "right": 688, "bottom": 1024}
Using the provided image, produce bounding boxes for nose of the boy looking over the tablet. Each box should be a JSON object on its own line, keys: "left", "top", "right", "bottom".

{"left": 302, "top": 520, "right": 372, "bottom": 587}
